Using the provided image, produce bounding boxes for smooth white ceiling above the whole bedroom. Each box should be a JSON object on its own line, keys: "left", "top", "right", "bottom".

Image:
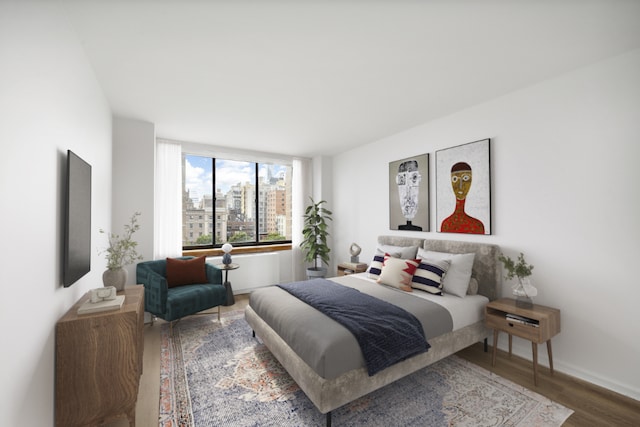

{"left": 60, "top": 0, "right": 640, "bottom": 157}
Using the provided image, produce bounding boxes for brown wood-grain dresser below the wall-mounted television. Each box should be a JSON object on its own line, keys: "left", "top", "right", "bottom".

{"left": 55, "top": 285, "right": 144, "bottom": 427}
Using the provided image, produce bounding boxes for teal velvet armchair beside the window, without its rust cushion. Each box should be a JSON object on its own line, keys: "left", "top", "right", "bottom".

{"left": 136, "top": 257, "right": 227, "bottom": 322}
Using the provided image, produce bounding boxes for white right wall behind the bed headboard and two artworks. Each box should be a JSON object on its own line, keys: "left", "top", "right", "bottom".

{"left": 332, "top": 51, "right": 640, "bottom": 399}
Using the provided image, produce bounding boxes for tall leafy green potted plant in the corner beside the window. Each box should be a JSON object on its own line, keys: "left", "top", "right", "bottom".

{"left": 300, "top": 197, "right": 333, "bottom": 278}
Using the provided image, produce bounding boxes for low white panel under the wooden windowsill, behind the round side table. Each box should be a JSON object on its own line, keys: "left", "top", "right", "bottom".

{"left": 207, "top": 252, "right": 281, "bottom": 294}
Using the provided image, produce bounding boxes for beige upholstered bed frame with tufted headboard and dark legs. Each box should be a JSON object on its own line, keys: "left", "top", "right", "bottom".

{"left": 245, "top": 236, "right": 502, "bottom": 426}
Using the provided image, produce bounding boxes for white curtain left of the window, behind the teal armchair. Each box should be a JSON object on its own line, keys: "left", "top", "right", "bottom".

{"left": 153, "top": 140, "right": 182, "bottom": 259}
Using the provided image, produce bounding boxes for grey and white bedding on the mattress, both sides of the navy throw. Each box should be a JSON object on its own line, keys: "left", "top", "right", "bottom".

{"left": 249, "top": 273, "right": 488, "bottom": 379}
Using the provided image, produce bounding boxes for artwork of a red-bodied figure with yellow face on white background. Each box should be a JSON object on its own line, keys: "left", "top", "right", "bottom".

{"left": 436, "top": 139, "right": 491, "bottom": 234}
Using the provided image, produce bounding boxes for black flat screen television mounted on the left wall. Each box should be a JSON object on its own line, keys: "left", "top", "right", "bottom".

{"left": 62, "top": 150, "right": 91, "bottom": 288}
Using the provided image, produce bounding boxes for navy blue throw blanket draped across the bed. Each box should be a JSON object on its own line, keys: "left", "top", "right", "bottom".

{"left": 278, "top": 279, "right": 431, "bottom": 376}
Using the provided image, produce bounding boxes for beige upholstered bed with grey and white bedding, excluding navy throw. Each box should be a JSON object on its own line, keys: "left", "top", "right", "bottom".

{"left": 245, "top": 236, "right": 502, "bottom": 426}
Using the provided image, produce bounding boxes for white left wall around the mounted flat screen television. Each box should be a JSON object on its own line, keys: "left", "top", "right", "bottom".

{"left": 0, "top": 2, "right": 111, "bottom": 426}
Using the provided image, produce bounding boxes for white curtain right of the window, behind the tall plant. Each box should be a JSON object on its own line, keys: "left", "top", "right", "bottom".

{"left": 291, "top": 159, "right": 311, "bottom": 281}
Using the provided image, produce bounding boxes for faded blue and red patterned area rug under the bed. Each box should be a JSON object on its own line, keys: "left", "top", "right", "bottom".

{"left": 159, "top": 311, "right": 573, "bottom": 427}
